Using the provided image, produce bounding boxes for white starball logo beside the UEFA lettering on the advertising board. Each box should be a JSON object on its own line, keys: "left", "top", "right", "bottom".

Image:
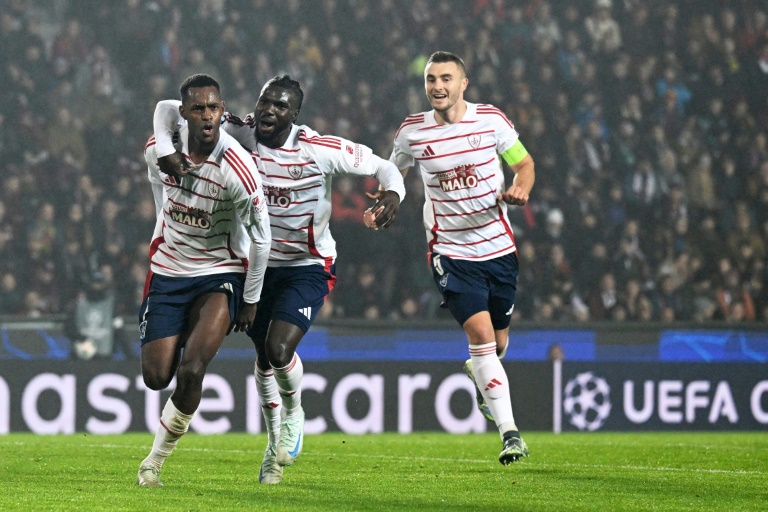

{"left": 563, "top": 372, "right": 611, "bottom": 431}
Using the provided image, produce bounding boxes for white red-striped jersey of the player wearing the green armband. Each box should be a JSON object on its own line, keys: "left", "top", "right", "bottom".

{"left": 390, "top": 102, "right": 518, "bottom": 261}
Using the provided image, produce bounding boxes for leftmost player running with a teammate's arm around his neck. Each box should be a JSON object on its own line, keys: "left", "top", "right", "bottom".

{"left": 138, "top": 75, "right": 271, "bottom": 487}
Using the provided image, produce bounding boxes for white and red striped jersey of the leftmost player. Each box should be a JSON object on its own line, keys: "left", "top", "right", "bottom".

{"left": 144, "top": 126, "right": 270, "bottom": 303}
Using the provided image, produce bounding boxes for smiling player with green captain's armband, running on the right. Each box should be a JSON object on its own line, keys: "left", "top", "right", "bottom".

{"left": 390, "top": 52, "right": 535, "bottom": 465}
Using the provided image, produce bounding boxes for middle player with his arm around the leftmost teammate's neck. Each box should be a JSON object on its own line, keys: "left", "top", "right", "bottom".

{"left": 147, "top": 76, "right": 405, "bottom": 484}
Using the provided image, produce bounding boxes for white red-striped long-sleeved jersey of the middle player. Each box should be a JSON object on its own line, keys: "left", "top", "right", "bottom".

{"left": 148, "top": 100, "right": 405, "bottom": 267}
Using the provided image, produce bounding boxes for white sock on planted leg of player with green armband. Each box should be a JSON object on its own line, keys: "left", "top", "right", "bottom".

{"left": 469, "top": 341, "right": 517, "bottom": 435}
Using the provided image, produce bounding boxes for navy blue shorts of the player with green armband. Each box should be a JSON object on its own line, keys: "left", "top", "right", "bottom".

{"left": 432, "top": 252, "right": 518, "bottom": 331}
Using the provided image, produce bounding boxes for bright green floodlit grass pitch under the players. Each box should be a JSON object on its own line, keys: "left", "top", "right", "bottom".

{"left": 0, "top": 432, "right": 768, "bottom": 512}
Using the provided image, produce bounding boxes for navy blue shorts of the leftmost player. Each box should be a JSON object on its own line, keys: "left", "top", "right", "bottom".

{"left": 139, "top": 272, "right": 245, "bottom": 345}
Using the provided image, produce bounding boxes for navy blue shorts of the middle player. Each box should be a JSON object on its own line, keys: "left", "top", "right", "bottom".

{"left": 248, "top": 265, "right": 336, "bottom": 341}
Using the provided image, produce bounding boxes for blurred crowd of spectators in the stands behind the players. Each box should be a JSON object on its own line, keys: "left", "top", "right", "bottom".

{"left": 0, "top": 0, "right": 768, "bottom": 322}
